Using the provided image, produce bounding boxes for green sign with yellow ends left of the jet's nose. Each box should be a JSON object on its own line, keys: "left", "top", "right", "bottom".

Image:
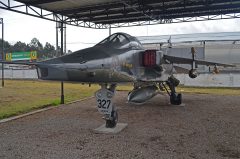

{"left": 6, "top": 51, "right": 37, "bottom": 61}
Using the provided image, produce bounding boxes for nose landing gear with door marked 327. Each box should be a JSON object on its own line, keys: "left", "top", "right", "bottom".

{"left": 95, "top": 84, "right": 118, "bottom": 128}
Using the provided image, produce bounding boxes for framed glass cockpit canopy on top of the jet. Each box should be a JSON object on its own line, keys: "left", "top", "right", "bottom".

{"left": 97, "top": 33, "right": 143, "bottom": 49}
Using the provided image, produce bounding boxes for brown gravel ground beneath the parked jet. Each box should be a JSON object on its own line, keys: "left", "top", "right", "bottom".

{"left": 0, "top": 92, "right": 240, "bottom": 159}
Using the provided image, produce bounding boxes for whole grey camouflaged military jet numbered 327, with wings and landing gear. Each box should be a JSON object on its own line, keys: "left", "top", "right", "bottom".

{"left": 0, "top": 33, "right": 232, "bottom": 128}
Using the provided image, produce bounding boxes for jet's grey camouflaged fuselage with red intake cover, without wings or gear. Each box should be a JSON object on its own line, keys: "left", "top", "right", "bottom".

{"left": 38, "top": 34, "right": 173, "bottom": 83}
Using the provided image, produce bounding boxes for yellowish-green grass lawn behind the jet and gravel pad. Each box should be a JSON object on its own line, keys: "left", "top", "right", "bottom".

{"left": 0, "top": 80, "right": 240, "bottom": 119}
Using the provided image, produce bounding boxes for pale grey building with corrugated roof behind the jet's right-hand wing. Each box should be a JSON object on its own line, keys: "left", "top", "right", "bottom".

{"left": 138, "top": 32, "right": 240, "bottom": 87}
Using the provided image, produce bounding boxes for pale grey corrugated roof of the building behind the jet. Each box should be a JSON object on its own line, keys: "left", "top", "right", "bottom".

{"left": 137, "top": 32, "right": 240, "bottom": 44}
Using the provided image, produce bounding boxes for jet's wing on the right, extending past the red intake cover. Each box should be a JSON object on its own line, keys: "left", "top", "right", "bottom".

{"left": 163, "top": 55, "right": 235, "bottom": 67}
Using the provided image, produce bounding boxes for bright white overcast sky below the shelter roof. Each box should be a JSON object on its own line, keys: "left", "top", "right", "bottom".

{"left": 0, "top": 1, "right": 240, "bottom": 51}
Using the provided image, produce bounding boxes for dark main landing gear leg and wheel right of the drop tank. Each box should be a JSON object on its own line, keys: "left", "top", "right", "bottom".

{"left": 162, "top": 76, "right": 182, "bottom": 105}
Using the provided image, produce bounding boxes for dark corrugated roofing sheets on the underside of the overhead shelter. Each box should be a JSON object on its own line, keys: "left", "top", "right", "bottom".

{"left": 16, "top": 0, "right": 240, "bottom": 25}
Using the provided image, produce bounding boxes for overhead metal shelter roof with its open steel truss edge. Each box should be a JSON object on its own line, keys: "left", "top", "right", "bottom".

{"left": 0, "top": 0, "right": 240, "bottom": 29}
